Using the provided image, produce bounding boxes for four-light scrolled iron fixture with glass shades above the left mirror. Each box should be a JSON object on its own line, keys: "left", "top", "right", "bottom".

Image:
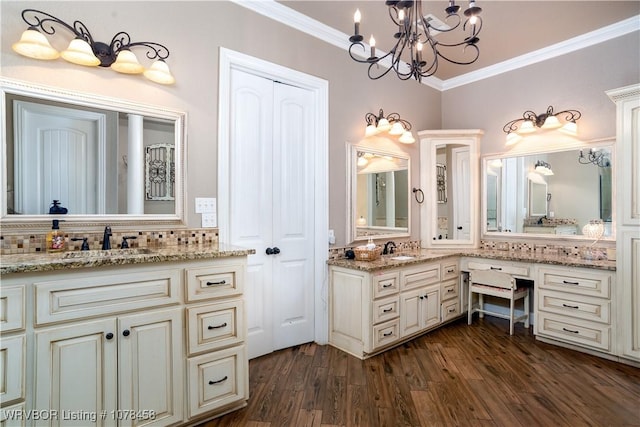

{"left": 12, "top": 9, "right": 175, "bottom": 84}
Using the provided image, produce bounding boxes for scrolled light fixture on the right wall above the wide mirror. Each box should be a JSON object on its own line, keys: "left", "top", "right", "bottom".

{"left": 502, "top": 106, "right": 582, "bottom": 145}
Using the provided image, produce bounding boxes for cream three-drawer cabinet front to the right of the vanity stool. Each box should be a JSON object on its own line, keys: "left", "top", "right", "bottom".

{"left": 535, "top": 265, "right": 615, "bottom": 354}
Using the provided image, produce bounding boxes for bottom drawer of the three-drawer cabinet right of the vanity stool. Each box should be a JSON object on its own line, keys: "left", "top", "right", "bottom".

{"left": 536, "top": 312, "right": 611, "bottom": 351}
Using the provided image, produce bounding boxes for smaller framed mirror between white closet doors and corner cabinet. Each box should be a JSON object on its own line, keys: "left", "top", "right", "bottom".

{"left": 347, "top": 144, "right": 411, "bottom": 241}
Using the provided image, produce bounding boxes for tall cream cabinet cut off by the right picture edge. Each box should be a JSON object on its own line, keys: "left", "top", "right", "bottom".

{"left": 607, "top": 84, "right": 640, "bottom": 362}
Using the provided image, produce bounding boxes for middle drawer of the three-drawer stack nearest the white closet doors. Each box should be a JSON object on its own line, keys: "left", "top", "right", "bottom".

{"left": 187, "top": 299, "right": 245, "bottom": 354}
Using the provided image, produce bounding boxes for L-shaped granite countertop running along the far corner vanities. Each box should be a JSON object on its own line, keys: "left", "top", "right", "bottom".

{"left": 327, "top": 249, "right": 616, "bottom": 271}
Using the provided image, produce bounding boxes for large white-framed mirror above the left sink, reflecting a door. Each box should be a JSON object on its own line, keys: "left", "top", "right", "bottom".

{"left": 0, "top": 79, "right": 185, "bottom": 227}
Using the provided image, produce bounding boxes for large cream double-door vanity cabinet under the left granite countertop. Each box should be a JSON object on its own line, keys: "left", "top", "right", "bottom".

{"left": 2, "top": 257, "right": 248, "bottom": 426}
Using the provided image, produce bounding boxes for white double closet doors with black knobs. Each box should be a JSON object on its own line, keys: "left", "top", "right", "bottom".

{"left": 229, "top": 70, "right": 314, "bottom": 358}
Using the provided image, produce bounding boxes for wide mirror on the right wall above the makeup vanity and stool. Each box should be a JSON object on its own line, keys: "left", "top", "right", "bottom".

{"left": 482, "top": 139, "right": 615, "bottom": 239}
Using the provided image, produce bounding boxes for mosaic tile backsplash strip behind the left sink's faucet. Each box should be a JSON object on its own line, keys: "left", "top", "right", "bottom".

{"left": 0, "top": 228, "right": 218, "bottom": 255}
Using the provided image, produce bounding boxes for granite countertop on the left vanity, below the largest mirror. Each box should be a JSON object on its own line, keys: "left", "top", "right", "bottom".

{"left": 0, "top": 244, "right": 255, "bottom": 274}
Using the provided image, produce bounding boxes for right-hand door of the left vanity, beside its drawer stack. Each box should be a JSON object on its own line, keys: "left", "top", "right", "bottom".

{"left": 118, "top": 308, "right": 184, "bottom": 426}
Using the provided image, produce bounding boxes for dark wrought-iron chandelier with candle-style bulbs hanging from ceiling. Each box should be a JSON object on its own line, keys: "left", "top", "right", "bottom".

{"left": 349, "top": 0, "right": 482, "bottom": 81}
